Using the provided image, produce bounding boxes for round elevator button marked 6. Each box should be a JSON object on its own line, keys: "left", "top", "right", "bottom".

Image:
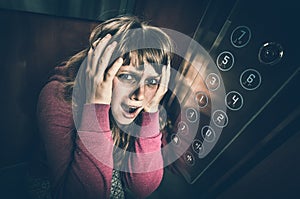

{"left": 240, "top": 69, "right": 261, "bottom": 90}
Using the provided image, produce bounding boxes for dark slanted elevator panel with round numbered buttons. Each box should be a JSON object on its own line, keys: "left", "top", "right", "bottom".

{"left": 170, "top": 1, "right": 299, "bottom": 183}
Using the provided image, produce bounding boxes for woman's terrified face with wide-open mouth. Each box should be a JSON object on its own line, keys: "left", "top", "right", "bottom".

{"left": 111, "top": 58, "right": 160, "bottom": 125}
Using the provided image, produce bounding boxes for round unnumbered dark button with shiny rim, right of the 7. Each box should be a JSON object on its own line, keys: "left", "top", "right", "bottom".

{"left": 258, "top": 42, "right": 283, "bottom": 65}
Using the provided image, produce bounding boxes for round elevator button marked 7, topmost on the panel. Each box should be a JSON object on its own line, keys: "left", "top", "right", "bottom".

{"left": 230, "top": 26, "right": 251, "bottom": 48}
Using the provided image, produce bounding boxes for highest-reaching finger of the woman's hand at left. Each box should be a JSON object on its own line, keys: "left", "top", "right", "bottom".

{"left": 90, "top": 34, "right": 111, "bottom": 74}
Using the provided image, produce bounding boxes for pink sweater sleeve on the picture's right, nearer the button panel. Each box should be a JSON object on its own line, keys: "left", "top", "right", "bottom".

{"left": 124, "top": 112, "right": 163, "bottom": 198}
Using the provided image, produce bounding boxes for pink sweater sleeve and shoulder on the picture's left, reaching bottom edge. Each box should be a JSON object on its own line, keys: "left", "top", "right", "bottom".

{"left": 37, "top": 81, "right": 112, "bottom": 199}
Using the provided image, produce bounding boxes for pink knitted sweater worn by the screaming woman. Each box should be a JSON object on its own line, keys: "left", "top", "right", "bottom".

{"left": 37, "top": 71, "right": 163, "bottom": 199}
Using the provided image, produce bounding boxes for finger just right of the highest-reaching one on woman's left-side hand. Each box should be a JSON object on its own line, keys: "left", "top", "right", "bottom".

{"left": 96, "top": 41, "right": 117, "bottom": 79}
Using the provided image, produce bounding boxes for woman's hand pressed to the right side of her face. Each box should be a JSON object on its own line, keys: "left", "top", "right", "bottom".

{"left": 144, "top": 62, "right": 171, "bottom": 113}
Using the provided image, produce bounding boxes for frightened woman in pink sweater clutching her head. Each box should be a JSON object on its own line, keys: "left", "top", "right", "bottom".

{"left": 38, "top": 14, "right": 172, "bottom": 199}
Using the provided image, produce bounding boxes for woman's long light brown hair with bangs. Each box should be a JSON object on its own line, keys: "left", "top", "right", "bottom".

{"left": 64, "top": 16, "right": 173, "bottom": 166}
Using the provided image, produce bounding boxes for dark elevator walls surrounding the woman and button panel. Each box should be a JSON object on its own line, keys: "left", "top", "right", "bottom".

{"left": 0, "top": 0, "right": 300, "bottom": 199}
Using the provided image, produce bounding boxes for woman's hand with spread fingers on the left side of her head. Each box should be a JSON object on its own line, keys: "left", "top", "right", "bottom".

{"left": 82, "top": 34, "right": 123, "bottom": 104}
